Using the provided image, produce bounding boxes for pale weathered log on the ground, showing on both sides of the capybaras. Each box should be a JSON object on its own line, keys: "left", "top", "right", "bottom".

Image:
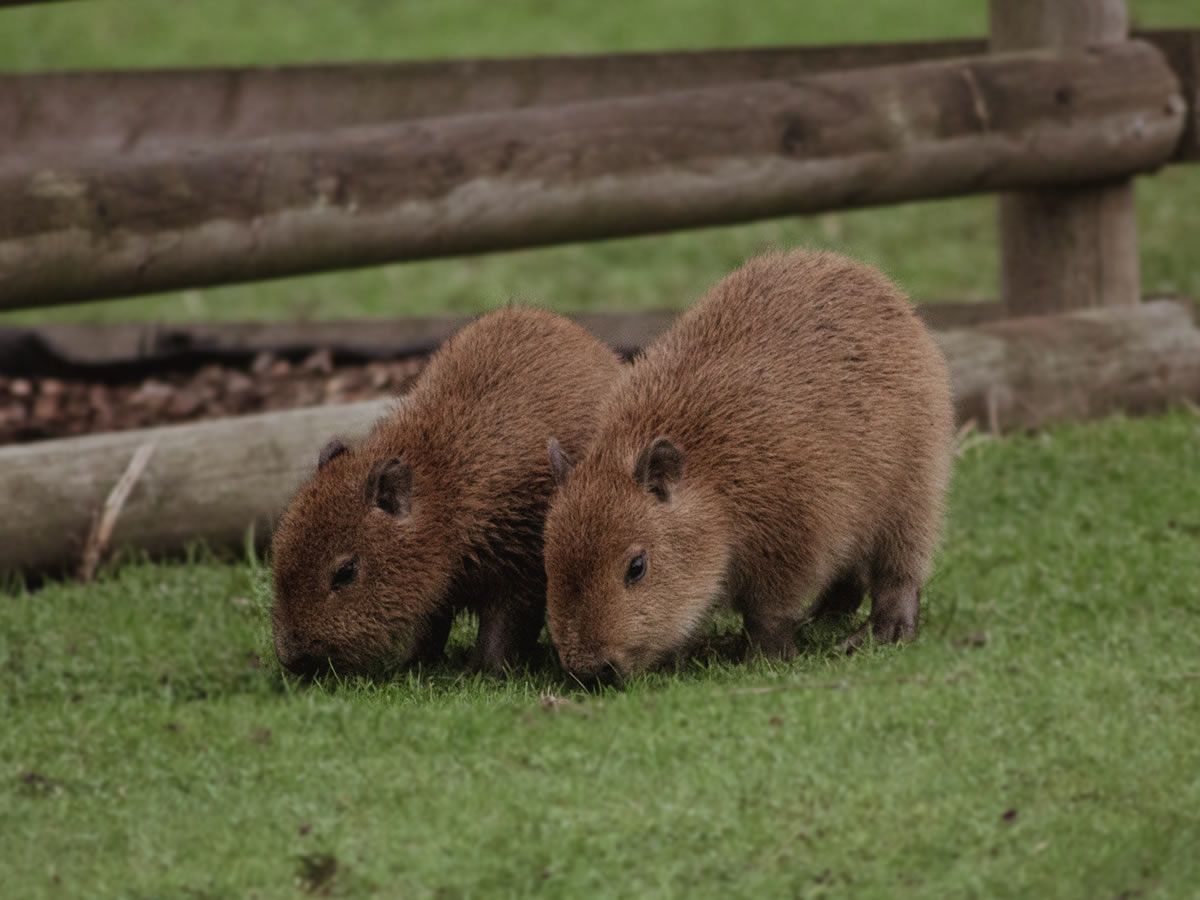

{"left": 0, "top": 301, "right": 1200, "bottom": 571}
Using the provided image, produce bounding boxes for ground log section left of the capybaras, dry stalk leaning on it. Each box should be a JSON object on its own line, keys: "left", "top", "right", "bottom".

{"left": 0, "top": 402, "right": 388, "bottom": 572}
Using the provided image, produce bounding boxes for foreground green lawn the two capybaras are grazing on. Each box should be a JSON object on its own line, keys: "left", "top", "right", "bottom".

{"left": 0, "top": 413, "right": 1200, "bottom": 898}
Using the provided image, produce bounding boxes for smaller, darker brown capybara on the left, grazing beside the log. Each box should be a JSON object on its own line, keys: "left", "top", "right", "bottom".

{"left": 271, "top": 307, "right": 622, "bottom": 674}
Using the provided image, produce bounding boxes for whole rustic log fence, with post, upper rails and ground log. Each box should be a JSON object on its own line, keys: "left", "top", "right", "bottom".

{"left": 0, "top": 0, "right": 1200, "bottom": 578}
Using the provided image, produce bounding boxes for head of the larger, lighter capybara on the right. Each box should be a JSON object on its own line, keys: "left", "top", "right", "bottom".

{"left": 545, "top": 437, "right": 730, "bottom": 682}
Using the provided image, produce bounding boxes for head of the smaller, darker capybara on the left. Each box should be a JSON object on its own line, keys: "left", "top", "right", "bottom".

{"left": 271, "top": 440, "right": 449, "bottom": 676}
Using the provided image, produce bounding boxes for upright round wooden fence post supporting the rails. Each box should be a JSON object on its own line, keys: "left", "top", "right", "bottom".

{"left": 990, "top": 0, "right": 1140, "bottom": 316}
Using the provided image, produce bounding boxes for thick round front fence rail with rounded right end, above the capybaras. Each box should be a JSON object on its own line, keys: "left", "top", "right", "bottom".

{"left": 0, "top": 42, "right": 1184, "bottom": 308}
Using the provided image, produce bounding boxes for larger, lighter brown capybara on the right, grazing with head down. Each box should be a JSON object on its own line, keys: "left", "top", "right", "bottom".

{"left": 545, "top": 251, "right": 953, "bottom": 679}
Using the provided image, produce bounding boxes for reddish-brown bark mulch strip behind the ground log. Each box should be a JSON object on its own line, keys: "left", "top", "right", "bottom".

{"left": 0, "top": 350, "right": 426, "bottom": 444}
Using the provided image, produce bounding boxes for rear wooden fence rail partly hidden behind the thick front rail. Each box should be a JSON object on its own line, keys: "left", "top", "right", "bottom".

{"left": 0, "top": 29, "right": 1200, "bottom": 160}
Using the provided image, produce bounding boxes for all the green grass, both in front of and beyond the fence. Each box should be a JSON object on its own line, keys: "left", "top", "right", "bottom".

{"left": 7, "top": 0, "right": 1200, "bottom": 898}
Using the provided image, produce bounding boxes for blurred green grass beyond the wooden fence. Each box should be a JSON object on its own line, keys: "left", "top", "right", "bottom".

{"left": 0, "top": 0, "right": 1200, "bottom": 323}
